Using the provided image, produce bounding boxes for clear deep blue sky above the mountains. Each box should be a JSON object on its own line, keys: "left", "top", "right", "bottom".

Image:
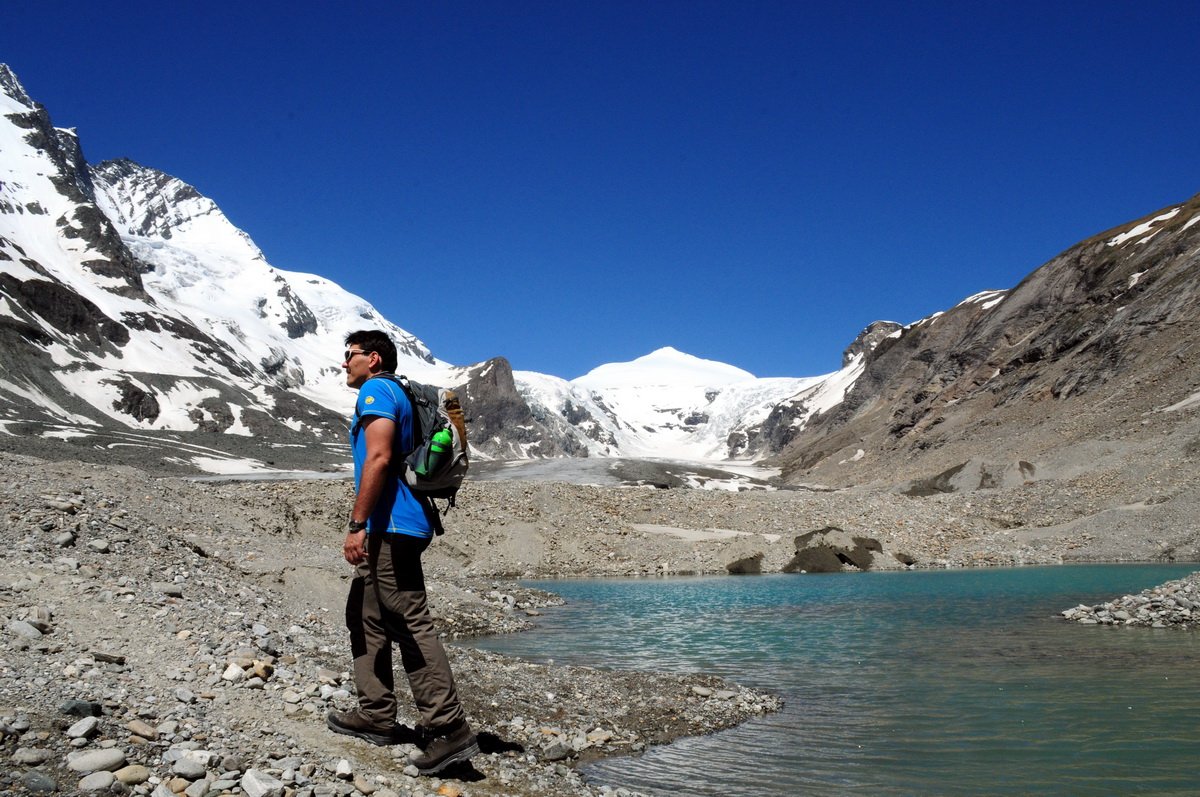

{"left": 0, "top": 0, "right": 1200, "bottom": 378}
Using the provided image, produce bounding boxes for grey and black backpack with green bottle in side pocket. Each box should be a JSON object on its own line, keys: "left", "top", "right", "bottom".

{"left": 364, "top": 373, "right": 469, "bottom": 534}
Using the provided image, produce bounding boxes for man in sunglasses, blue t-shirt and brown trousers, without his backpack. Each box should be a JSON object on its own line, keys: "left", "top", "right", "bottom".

{"left": 325, "top": 330, "right": 479, "bottom": 774}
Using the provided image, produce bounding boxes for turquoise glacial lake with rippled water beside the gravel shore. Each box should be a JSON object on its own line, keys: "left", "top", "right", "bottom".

{"left": 470, "top": 564, "right": 1200, "bottom": 797}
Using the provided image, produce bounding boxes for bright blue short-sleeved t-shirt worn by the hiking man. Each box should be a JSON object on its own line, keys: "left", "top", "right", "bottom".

{"left": 350, "top": 379, "right": 433, "bottom": 538}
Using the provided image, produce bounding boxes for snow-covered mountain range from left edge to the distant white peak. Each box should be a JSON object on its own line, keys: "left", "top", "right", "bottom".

{"left": 0, "top": 65, "right": 853, "bottom": 467}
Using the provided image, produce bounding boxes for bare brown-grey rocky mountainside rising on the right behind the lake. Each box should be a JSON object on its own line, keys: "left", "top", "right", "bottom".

{"left": 779, "top": 197, "right": 1200, "bottom": 495}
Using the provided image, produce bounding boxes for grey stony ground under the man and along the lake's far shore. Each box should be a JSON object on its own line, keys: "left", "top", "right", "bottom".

{"left": 0, "top": 444, "right": 1200, "bottom": 797}
